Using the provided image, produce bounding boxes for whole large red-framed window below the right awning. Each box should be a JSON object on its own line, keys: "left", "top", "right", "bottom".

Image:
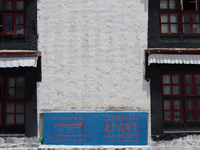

{"left": 162, "top": 73, "right": 200, "bottom": 126}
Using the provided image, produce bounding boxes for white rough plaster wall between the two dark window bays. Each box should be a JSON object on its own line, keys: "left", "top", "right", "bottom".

{"left": 38, "top": 0, "right": 150, "bottom": 110}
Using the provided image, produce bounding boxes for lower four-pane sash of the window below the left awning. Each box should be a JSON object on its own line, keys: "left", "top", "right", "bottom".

{"left": 5, "top": 102, "right": 25, "bottom": 125}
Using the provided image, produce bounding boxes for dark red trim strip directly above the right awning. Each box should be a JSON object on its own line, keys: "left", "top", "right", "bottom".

{"left": 149, "top": 49, "right": 200, "bottom": 54}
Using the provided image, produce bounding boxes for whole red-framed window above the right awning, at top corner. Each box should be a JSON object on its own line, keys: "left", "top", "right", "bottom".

{"left": 160, "top": 0, "right": 200, "bottom": 34}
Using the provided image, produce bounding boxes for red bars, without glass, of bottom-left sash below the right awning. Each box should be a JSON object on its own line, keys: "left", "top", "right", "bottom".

{"left": 163, "top": 98, "right": 183, "bottom": 122}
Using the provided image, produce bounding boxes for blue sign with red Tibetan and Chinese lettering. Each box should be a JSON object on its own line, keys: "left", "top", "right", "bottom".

{"left": 44, "top": 112, "right": 148, "bottom": 145}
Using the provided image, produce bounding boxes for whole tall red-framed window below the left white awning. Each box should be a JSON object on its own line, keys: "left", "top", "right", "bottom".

{"left": 0, "top": 76, "right": 25, "bottom": 133}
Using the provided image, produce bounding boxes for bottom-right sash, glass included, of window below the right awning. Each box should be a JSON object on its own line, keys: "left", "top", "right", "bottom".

{"left": 186, "top": 99, "right": 200, "bottom": 122}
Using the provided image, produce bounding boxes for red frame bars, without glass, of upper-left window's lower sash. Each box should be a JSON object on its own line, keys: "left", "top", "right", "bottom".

{"left": 2, "top": 13, "right": 25, "bottom": 35}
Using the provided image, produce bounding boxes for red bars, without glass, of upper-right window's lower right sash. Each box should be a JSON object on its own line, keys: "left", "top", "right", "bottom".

{"left": 181, "top": 12, "right": 200, "bottom": 34}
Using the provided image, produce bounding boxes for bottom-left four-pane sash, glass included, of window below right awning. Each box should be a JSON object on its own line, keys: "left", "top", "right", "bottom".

{"left": 163, "top": 99, "right": 183, "bottom": 122}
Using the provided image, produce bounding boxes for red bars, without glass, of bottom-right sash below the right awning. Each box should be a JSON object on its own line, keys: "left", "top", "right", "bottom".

{"left": 185, "top": 99, "right": 200, "bottom": 122}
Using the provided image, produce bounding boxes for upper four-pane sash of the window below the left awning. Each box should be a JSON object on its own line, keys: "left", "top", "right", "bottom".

{"left": 5, "top": 77, "right": 25, "bottom": 99}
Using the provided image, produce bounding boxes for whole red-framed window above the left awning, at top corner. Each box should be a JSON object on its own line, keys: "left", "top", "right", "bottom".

{"left": 0, "top": 0, "right": 25, "bottom": 35}
